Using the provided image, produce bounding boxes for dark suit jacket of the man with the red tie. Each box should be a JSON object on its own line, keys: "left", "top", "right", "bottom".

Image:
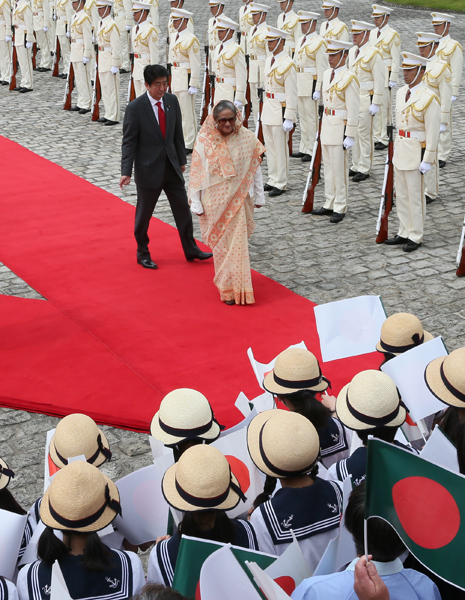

{"left": 121, "top": 93, "right": 187, "bottom": 189}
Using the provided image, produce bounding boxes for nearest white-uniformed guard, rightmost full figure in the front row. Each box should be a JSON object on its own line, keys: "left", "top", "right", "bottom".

{"left": 384, "top": 52, "right": 441, "bottom": 252}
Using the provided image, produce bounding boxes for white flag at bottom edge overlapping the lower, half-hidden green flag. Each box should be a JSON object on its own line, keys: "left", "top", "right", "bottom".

{"left": 200, "top": 544, "right": 261, "bottom": 600}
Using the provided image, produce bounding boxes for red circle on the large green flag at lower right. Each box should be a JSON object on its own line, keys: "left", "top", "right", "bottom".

{"left": 392, "top": 476, "right": 460, "bottom": 550}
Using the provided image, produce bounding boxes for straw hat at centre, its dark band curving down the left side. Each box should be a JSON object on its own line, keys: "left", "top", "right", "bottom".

{"left": 247, "top": 409, "right": 320, "bottom": 478}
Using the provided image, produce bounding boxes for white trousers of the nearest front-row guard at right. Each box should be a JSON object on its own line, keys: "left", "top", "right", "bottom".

{"left": 394, "top": 167, "right": 426, "bottom": 244}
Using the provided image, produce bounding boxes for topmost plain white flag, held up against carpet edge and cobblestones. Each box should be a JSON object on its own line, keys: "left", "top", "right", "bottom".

{"left": 313, "top": 296, "right": 386, "bottom": 362}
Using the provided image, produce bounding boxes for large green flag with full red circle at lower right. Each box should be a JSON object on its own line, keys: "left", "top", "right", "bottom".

{"left": 365, "top": 439, "right": 465, "bottom": 589}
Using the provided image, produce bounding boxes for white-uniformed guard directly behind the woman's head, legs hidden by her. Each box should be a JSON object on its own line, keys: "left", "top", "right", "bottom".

{"left": 215, "top": 15, "right": 247, "bottom": 108}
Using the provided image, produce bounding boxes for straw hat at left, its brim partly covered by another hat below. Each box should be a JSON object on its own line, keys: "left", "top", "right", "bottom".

{"left": 49, "top": 413, "right": 111, "bottom": 469}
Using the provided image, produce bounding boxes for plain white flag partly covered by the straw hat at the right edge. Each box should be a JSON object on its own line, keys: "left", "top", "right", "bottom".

{"left": 381, "top": 337, "right": 447, "bottom": 423}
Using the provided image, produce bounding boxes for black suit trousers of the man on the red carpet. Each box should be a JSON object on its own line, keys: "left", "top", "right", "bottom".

{"left": 134, "top": 158, "right": 199, "bottom": 260}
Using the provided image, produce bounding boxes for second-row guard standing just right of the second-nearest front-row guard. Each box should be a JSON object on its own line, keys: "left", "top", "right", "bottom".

{"left": 348, "top": 21, "right": 386, "bottom": 181}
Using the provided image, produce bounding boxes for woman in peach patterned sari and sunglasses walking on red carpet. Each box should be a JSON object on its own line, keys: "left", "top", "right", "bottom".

{"left": 189, "top": 100, "right": 265, "bottom": 304}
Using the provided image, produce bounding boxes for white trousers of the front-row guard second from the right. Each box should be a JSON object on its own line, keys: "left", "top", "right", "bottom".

{"left": 321, "top": 141, "right": 349, "bottom": 215}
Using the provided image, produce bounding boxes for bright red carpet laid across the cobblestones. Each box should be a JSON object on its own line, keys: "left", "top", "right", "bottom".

{"left": 0, "top": 138, "right": 380, "bottom": 431}
